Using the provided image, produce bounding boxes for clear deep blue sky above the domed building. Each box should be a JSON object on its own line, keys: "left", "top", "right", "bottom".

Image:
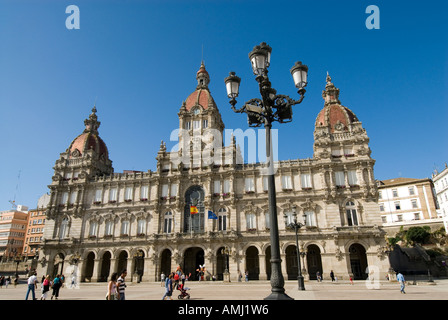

{"left": 0, "top": 0, "right": 448, "bottom": 210}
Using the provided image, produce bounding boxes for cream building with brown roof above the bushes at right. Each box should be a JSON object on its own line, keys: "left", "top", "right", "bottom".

{"left": 377, "top": 178, "right": 442, "bottom": 236}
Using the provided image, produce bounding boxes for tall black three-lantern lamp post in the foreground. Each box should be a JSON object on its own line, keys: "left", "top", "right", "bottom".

{"left": 224, "top": 42, "right": 308, "bottom": 300}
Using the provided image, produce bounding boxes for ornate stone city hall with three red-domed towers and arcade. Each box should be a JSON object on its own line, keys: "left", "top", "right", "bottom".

{"left": 38, "top": 64, "right": 389, "bottom": 281}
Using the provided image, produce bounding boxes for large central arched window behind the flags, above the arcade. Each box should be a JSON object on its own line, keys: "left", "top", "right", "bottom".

{"left": 184, "top": 186, "right": 205, "bottom": 233}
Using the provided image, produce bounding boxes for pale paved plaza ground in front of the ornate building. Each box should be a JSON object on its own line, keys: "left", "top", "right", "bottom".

{"left": 0, "top": 279, "right": 448, "bottom": 301}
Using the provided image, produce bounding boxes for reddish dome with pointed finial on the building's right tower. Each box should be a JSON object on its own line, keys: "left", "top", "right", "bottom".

{"left": 315, "top": 74, "right": 359, "bottom": 133}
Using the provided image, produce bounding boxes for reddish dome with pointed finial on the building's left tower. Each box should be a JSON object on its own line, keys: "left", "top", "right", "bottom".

{"left": 68, "top": 107, "right": 109, "bottom": 159}
